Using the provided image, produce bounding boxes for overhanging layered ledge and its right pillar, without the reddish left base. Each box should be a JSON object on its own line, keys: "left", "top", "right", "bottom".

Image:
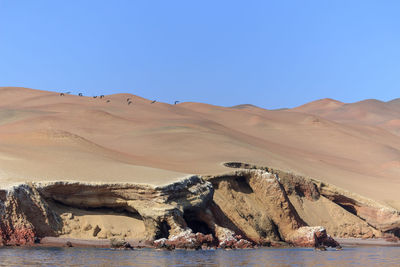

{"left": 37, "top": 176, "right": 213, "bottom": 240}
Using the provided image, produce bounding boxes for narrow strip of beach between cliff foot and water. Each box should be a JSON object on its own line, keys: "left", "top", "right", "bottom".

{"left": 11, "top": 237, "right": 400, "bottom": 249}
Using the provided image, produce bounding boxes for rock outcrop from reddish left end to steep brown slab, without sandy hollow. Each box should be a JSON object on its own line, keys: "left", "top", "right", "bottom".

{"left": 0, "top": 170, "right": 340, "bottom": 249}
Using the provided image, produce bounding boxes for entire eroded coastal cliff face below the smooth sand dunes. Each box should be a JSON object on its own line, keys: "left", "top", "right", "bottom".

{"left": 0, "top": 163, "right": 400, "bottom": 248}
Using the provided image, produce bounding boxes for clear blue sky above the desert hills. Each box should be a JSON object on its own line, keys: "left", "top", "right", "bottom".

{"left": 0, "top": 0, "right": 400, "bottom": 108}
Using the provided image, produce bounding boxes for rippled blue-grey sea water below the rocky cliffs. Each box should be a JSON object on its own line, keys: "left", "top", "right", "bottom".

{"left": 0, "top": 247, "right": 400, "bottom": 267}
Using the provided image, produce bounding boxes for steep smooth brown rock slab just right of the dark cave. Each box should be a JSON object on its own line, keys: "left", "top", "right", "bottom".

{"left": 208, "top": 170, "right": 305, "bottom": 243}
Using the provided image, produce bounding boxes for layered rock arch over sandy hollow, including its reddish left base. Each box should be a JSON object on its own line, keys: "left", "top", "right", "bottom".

{"left": 0, "top": 176, "right": 213, "bottom": 248}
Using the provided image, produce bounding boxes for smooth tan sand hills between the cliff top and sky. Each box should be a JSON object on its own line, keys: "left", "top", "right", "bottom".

{"left": 0, "top": 87, "right": 400, "bottom": 208}
